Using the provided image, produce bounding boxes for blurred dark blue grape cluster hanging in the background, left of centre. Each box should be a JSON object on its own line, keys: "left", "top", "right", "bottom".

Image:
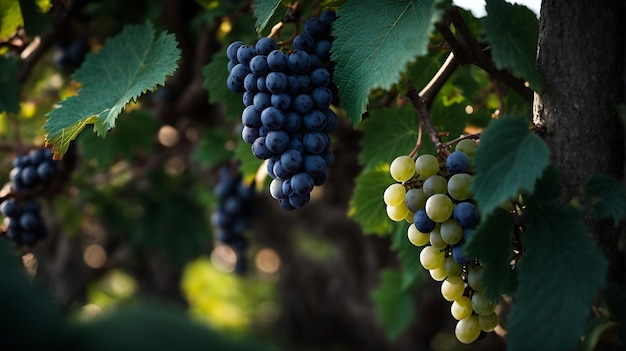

{"left": 212, "top": 166, "right": 256, "bottom": 273}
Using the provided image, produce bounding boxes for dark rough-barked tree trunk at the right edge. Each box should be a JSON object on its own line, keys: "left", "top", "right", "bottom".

{"left": 534, "top": 0, "right": 626, "bottom": 316}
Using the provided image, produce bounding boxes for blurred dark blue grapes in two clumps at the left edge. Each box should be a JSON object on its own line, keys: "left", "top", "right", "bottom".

{"left": 0, "top": 149, "right": 57, "bottom": 246}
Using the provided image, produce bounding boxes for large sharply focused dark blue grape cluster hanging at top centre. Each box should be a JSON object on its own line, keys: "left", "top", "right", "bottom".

{"left": 226, "top": 11, "right": 339, "bottom": 210}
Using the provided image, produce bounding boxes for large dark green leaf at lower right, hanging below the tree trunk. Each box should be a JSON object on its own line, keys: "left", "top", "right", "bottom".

{"left": 508, "top": 204, "right": 608, "bottom": 351}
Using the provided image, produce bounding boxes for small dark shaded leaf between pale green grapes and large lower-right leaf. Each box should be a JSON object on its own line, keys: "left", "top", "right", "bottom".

{"left": 464, "top": 209, "right": 517, "bottom": 301}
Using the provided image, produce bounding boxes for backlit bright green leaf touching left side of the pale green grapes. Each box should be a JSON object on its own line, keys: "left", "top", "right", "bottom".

{"left": 348, "top": 163, "right": 396, "bottom": 235}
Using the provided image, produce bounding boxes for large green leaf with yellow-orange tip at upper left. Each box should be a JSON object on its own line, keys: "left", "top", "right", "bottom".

{"left": 44, "top": 22, "right": 180, "bottom": 158}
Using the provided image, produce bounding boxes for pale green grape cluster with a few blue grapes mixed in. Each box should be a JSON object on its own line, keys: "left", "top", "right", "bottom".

{"left": 383, "top": 139, "right": 498, "bottom": 344}
